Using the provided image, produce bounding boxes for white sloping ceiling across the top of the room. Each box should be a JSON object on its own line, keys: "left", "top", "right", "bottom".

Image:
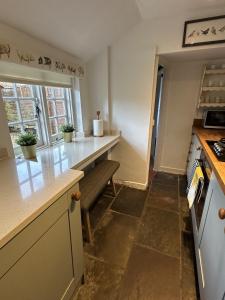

{"left": 0, "top": 0, "right": 225, "bottom": 61}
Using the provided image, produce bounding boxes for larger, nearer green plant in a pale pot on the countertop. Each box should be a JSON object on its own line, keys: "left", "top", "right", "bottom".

{"left": 16, "top": 132, "right": 37, "bottom": 159}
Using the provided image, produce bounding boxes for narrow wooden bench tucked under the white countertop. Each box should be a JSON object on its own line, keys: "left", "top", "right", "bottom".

{"left": 80, "top": 160, "right": 120, "bottom": 243}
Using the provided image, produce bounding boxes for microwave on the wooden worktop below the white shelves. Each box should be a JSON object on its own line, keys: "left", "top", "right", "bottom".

{"left": 203, "top": 109, "right": 225, "bottom": 129}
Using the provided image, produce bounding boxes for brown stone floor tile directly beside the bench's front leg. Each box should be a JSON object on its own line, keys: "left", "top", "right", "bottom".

{"left": 85, "top": 212, "right": 138, "bottom": 268}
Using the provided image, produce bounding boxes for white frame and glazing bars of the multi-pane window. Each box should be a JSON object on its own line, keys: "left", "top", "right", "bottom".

{"left": 1, "top": 80, "right": 75, "bottom": 157}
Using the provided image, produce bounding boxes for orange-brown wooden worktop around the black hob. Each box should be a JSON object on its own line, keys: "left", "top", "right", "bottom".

{"left": 193, "top": 127, "right": 225, "bottom": 193}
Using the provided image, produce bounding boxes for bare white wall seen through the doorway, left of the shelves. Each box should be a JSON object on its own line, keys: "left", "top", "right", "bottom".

{"left": 158, "top": 61, "right": 204, "bottom": 174}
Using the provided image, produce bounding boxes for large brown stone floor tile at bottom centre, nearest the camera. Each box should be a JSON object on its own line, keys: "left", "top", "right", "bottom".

{"left": 119, "top": 245, "right": 180, "bottom": 300}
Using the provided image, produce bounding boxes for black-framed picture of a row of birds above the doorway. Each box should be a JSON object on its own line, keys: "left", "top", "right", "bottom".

{"left": 182, "top": 16, "right": 225, "bottom": 47}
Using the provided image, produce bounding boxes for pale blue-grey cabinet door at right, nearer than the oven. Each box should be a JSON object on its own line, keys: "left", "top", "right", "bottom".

{"left": 199, "top": 177, "right": 225, "bottom": 300}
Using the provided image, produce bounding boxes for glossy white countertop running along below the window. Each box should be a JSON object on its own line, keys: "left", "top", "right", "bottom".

{"left": 0, "top": 136, "right": 119, "bottom": 248}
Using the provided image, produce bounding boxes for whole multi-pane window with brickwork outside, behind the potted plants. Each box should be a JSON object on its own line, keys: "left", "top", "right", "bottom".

{"left": 0, "top": 82, "right": 73, "bottom": 156}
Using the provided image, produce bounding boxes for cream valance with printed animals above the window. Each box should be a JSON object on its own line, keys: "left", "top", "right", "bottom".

{"left": 0, "top": 42, "right": 84, "bottom": 78}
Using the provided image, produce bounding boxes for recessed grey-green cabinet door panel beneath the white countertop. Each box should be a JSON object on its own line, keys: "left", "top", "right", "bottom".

{"left": 0, "top": 211, "right": 75, "bottom": 300}
